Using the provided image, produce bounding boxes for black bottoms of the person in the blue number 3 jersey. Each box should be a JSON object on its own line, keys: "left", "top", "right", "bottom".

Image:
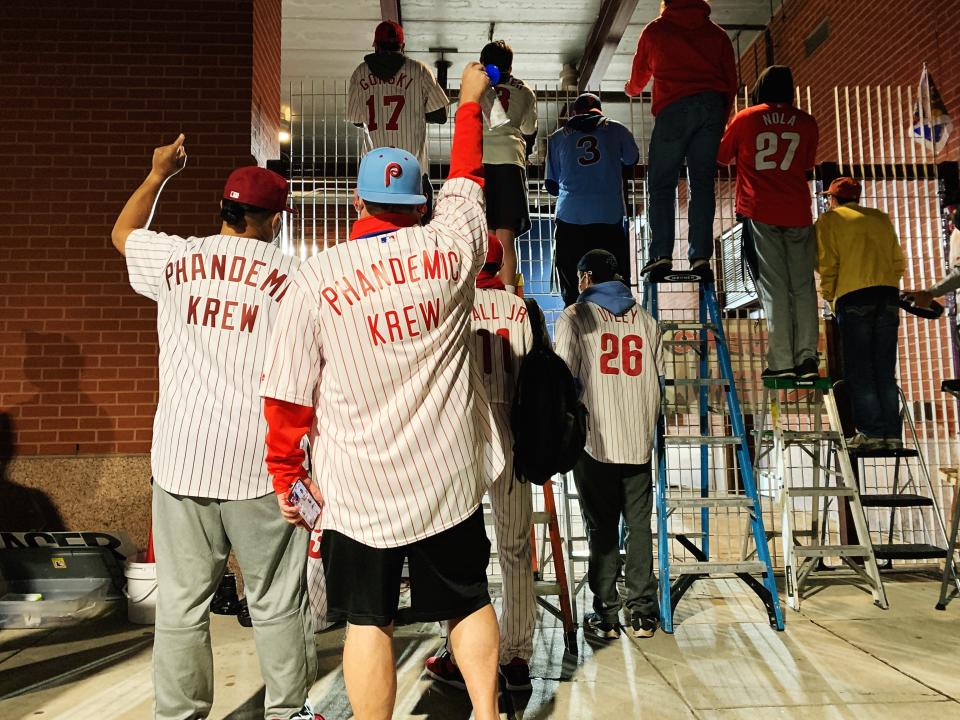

{"left": 553, "top": 220, "right": 630, "bottom": 306}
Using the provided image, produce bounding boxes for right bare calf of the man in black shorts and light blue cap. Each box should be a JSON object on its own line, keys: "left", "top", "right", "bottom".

{"left": 448, "top": 605, "right": 500, "bottom": 720}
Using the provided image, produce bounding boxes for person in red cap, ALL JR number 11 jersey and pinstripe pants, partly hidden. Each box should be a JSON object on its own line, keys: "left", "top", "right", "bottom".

{"left": 426, "top": 233, "right": 550, "bottom": 691}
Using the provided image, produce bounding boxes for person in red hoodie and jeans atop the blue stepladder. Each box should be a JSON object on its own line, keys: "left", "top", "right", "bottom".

{"left": 624, "top": 0, "right": 737, "bottom": 275}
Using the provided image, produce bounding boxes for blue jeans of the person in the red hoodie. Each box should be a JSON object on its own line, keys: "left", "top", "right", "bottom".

{"left": 647, "top": 92, "right": 727, "bottom": 258}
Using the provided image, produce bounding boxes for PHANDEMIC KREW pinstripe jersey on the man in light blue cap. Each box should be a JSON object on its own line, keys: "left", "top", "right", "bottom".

{"left": 261, "top": 178, "right": 504, "bottom": 548}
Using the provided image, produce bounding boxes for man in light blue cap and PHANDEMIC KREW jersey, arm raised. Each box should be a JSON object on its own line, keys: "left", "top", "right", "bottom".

{"left": 260, "top": 63, "right": 504, "bottom": 720}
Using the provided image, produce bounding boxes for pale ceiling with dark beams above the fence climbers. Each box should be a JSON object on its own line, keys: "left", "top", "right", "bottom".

{"left": 282, "top": 0, "right": 780, "bottom": 90}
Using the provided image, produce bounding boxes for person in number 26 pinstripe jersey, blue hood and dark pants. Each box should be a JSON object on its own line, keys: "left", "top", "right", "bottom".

{"left": 556, "top": 250, "right": 665, "bottom": 639}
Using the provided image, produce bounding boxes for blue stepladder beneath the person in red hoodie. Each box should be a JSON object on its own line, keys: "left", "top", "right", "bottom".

{"left": 644, "top": 271, "right": 783, "bottom": 633}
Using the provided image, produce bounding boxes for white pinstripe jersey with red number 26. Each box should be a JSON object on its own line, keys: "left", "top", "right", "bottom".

{"left": 556, "top": 302, "right": 664, "bottom": 464}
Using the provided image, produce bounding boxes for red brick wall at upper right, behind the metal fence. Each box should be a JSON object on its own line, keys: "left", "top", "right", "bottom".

{"left": 740, "top": 0, "right": 960, "bottom": 161}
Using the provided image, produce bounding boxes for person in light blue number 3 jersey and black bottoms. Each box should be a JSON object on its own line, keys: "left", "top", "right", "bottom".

{"left": 544, "top": 93, "right": 640, "bottom": 307}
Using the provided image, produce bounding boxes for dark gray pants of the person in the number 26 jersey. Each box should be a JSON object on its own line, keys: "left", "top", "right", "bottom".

{"left": 573, "top": 451, "right": 660, "bottom": 622}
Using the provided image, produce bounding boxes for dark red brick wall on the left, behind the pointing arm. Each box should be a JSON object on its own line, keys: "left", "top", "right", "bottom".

{"left": 0, "top": 0, "right": 280, "bottom": 456}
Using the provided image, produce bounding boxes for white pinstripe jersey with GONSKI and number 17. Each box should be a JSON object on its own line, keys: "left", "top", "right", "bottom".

{"left": 347, "top": 58, "right": 450, "bottom": 170}
